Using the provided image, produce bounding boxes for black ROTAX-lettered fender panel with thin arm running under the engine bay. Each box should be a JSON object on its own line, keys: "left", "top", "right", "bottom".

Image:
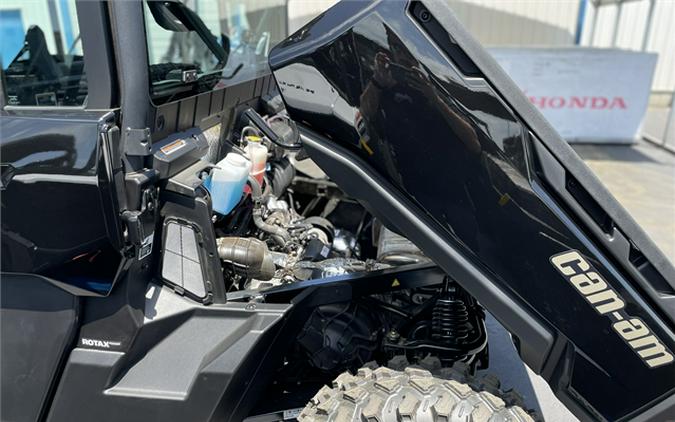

{"left": 47, "top": 265, "right": 445, "bottom": 422}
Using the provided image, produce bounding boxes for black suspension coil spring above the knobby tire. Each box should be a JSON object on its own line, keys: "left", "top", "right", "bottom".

{"left": 431, "top": 296, "right": 470, "bottom": 343}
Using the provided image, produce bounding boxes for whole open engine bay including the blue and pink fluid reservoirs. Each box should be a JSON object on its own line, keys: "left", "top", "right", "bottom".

{"left": 193, "top": 109, "right": 429, "bottom": 292}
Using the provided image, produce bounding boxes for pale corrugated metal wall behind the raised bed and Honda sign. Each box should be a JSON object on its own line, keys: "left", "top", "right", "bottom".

{"left": 288, "top": 0, "right": 675, "bottom": 92}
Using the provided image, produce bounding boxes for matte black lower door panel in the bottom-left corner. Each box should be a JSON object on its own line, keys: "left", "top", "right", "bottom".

{"left": 0, "top": 275, "right": 79, "bottom": 421}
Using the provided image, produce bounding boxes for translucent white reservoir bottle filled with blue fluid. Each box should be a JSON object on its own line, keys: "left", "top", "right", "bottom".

{"left": 205, "top": 152, "right": 251, "bottom": 215}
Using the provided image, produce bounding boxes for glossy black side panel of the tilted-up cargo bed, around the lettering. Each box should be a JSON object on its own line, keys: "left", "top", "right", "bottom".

{"left": 270, "top": 1, "right": 675, "bottom": 420}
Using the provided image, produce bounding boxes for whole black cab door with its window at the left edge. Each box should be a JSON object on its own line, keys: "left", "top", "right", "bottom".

{"left": 0, "top": 0, "right": 123, "bottom": 421}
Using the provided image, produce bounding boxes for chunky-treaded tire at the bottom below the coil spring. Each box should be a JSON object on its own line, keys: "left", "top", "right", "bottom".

{"left": 298, "top": 367, "right": 534, "bottom": 422}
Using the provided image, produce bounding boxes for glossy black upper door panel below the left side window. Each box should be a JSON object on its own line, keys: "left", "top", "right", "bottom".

{"left": 0, "top": 111, "right": 121, "bottom": 293}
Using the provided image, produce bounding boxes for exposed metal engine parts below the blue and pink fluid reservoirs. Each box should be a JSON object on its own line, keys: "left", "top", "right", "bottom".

{"left": 215, "top": 157, "right": 428, "bottom": 292}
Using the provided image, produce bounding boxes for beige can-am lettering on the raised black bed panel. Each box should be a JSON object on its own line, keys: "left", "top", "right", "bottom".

{"left": 551, "top": 251, "right": 673, "bottom": 368}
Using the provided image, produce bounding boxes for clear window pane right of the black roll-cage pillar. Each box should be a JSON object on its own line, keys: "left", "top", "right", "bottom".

{"left": 144, "top": 0, "right": 287, "bottom": 103}
